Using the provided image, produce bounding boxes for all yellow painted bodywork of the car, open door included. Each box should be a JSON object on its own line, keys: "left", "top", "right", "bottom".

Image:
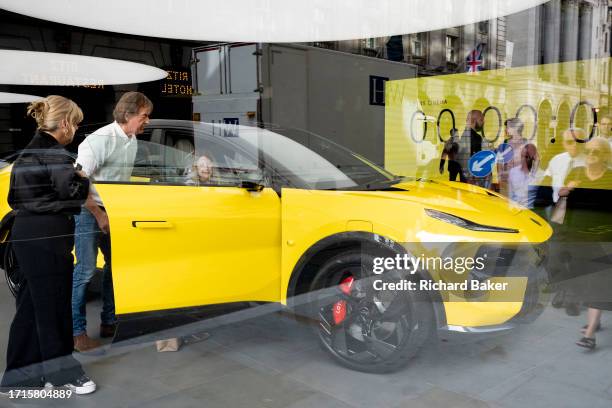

{"left": 0, "top": 158, "right": 552, "bottom": 326}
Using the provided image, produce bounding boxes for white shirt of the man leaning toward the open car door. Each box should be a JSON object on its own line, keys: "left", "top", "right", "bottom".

{"left": 77, "top": 122, "right": 137, "bottom": 205}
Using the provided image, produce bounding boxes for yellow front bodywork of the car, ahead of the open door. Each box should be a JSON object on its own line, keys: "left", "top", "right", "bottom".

{"left": 281, "top": 186, "right": 552, "bottom": 326}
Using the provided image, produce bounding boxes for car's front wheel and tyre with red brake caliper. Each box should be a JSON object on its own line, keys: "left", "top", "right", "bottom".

{"left": 308, "top": 251, "right": 435, "bottom": 373}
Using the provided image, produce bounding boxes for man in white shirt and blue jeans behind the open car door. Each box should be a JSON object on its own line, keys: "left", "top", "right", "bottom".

{"left": 72, "top": 92, "right": 153, "bottom": 352}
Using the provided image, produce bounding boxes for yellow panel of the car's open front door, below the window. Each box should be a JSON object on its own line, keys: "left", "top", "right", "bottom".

{"left": 96, "top": 184, "right": 281, "bottom": 314}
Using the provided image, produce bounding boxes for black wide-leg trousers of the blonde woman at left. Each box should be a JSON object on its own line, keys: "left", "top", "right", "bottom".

{"left": 2, "top": 214, "right": 83, "bottom": 387}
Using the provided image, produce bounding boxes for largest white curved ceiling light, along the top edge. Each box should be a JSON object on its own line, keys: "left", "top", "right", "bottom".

{"left": 0, "top": 0, "right": 548, "bottom": 42}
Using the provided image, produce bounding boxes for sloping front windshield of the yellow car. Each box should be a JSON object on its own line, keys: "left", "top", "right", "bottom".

{"left": 194, "top": 123, "right": 399, "bottom": 190}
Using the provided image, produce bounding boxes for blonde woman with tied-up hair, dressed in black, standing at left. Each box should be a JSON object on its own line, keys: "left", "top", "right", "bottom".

{"left": 2, "top": 95, "right": 96, "bottom": 394}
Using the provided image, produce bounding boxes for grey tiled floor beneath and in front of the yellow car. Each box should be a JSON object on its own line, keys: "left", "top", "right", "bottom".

{"left": 0, "top": 283, "right": 612, "bottom": 408}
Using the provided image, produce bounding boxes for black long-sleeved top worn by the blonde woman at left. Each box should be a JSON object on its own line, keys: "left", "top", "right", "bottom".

{"left": 8, "top": 132, "right": 89, "bottom": 215}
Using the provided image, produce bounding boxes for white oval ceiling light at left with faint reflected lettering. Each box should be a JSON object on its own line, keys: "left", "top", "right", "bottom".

{"left": 0, "top": 50, "right": 168, "bottom": 86}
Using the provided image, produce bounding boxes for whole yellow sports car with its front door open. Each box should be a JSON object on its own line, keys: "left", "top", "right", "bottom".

{"left": 0, "top": 120, "right": 552, "bottom": 372}
